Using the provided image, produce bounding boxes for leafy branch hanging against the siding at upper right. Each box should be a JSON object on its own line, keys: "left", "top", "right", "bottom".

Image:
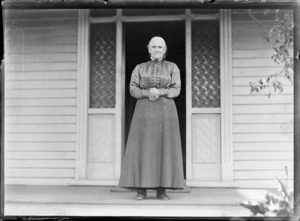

{"left": 235, "top": 0, "right": 294, "bottom": 97}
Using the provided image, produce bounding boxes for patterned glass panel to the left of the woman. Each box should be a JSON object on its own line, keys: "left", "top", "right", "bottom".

{"left": 90, "top": 23, "right": 116, "bottom": 108}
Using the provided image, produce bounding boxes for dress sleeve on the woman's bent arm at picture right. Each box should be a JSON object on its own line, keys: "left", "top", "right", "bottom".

{"left": 159, "top": 64, "right": 181, "bottom": 98}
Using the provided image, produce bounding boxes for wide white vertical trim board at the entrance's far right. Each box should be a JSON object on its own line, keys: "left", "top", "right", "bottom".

{"left": 220, "top": 9, "right": 233, "bottom": 182}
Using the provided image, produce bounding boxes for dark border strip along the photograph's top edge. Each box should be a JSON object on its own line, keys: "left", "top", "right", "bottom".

{"left": 2, "top": 0, "right": 297, "bottom": 9}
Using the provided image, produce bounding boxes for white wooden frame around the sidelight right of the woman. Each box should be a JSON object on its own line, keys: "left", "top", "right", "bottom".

{"left": 186, "top": 9, "right": 237, "bottom": 187}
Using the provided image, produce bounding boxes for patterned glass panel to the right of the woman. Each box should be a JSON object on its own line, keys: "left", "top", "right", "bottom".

{"left": 192, "top": 21, "right": 220, "bottom": 108}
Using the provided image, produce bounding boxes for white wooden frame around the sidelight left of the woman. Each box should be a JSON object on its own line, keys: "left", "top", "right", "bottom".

{"left": 70, "top": 9, "right": 124, "bottom": 185}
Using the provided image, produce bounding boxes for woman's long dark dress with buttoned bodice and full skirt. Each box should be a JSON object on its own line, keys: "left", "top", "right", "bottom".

{"left": 119, "top": 60, "right": 184, "bottom": 189}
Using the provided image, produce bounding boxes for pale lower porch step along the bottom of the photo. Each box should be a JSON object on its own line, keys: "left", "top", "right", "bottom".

{"left": 5, "top": 202, "right": 251, "bottom": 217}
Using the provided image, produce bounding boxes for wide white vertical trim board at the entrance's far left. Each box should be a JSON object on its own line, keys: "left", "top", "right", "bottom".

{"left": 75, "top": 9, "right": 89, "bottom": 179}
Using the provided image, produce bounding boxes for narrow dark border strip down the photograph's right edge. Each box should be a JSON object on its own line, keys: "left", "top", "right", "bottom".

{"left": 294, "top": 2, "right": 300, "bottom": 217}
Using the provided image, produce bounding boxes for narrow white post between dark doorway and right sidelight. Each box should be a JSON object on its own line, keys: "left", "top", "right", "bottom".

{"left": 185, "top": 9, "right": 193, "bottom": 182}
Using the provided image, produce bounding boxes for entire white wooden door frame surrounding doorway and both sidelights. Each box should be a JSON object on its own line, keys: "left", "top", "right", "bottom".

{"left": 71, "top": 9, "right": 236, "bottom": 187}
